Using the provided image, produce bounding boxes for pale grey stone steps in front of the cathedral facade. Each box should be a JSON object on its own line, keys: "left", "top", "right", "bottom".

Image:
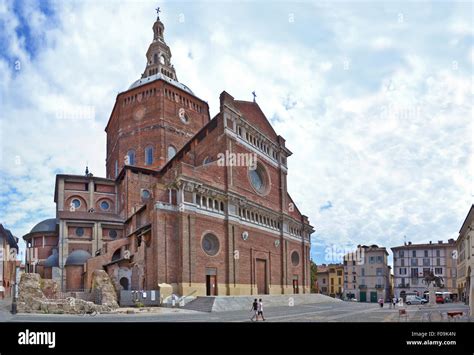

{"left": 183, "top": 293, "right": 342, "bottom": 312}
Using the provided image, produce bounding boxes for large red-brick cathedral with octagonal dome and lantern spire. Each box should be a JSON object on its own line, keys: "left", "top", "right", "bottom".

{"left": 23, "top": 9, "right": 313, "bottom": 296}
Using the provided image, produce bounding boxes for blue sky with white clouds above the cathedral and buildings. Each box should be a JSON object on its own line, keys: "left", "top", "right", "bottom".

{"left": 0, "top": 0, "right": 474, "bottom": 263}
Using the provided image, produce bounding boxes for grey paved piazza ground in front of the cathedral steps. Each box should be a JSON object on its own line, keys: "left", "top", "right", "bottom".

{"left": 0, "top": 301, "right": 468, "bottom": 322}
